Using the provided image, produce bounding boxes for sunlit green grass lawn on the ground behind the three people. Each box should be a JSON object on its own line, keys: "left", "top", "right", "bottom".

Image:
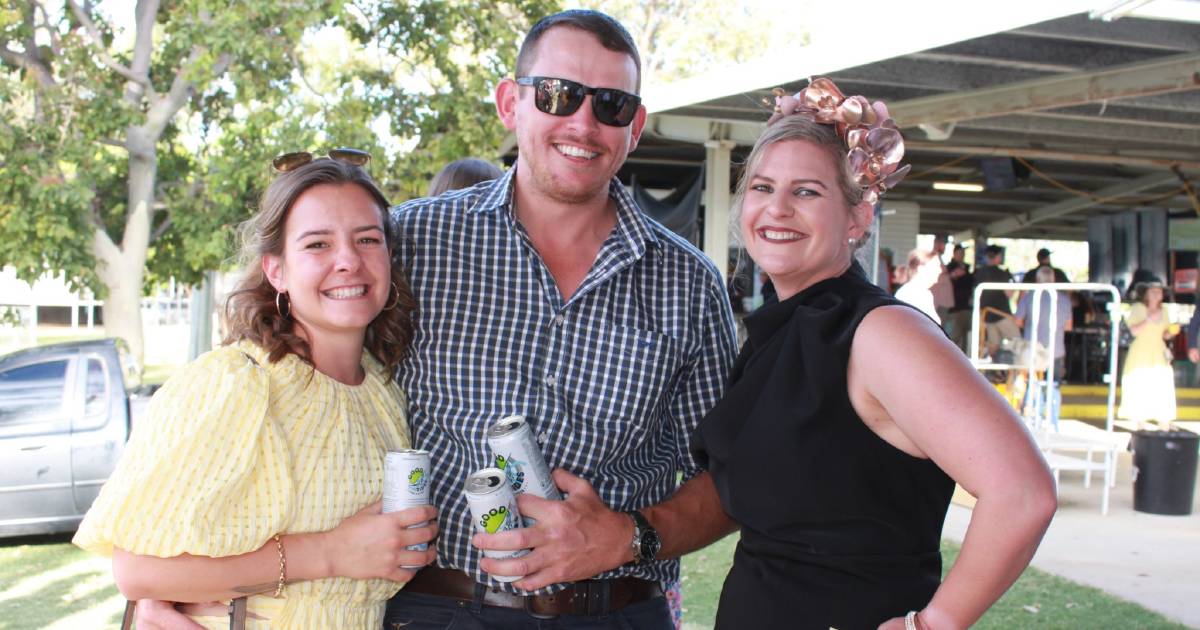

{"left": 0, "top": 535, "right": 1184, "bottom": 630}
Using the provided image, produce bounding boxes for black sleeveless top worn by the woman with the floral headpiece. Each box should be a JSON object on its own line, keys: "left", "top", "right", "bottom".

{"left": 694, "top": 264, "right": 954, "bottom": 630}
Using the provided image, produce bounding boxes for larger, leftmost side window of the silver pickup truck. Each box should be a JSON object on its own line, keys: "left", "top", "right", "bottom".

{"left": 0, "top": 359, "right": 70, "bottom": 437}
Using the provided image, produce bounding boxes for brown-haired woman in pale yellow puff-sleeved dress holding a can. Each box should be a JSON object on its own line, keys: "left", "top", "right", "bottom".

{"left": 74, "top": 150, "right": 437, "bottom": 629}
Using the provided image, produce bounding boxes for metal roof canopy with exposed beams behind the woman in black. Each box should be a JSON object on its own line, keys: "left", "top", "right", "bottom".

{"left": 622, "top": 13, "right": 1200, "bottom": 240}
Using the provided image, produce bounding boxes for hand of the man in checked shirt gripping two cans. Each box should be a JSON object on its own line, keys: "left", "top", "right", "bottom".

{"left": 472, "top": 469, "right": 634, "bottom": 590}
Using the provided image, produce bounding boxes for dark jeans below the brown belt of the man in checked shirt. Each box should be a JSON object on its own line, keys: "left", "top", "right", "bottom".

{"left": 383, "top": 590, "right": 674, "bottom": 630}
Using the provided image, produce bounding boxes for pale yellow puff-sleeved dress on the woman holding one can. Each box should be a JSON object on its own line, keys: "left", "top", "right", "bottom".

{"left": 74, "top": 342, "right": 409, "bottom": 630}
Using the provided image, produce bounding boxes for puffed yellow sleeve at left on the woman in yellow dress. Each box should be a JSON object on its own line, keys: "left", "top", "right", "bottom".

{"left": 74, "top": 343, "right": 293, "bottom": 557}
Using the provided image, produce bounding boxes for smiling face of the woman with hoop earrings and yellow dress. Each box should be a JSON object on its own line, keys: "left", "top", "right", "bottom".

{"left": 263, "top": 184, "right": 391, "bottom": 341}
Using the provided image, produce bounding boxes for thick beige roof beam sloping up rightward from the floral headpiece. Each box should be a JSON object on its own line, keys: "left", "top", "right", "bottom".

{"left": 888, "top": 53, "right": 1200, "bottom": 127}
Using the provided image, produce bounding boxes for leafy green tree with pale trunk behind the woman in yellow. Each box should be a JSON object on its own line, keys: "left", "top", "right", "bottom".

{"left": 0, "top": 0, "right": 556, "bottom": 355}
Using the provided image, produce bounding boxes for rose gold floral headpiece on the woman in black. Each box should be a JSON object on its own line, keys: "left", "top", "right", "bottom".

{"left": 767, "top": 77, "right": 911, "bottom": 204}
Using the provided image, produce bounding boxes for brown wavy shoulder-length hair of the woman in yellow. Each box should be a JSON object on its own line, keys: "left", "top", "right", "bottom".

{"left": 223, "top": 158, "right": 416, "bottom": 372}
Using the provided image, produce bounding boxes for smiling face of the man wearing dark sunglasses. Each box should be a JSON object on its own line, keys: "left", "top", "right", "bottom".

{"left": 497, "top": 26, "right": 646, "bottom": 203}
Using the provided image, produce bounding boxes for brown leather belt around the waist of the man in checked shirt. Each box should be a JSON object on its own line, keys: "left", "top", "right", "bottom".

{"left": 404, "top": 566, "right": 662, "bottom": 618}
